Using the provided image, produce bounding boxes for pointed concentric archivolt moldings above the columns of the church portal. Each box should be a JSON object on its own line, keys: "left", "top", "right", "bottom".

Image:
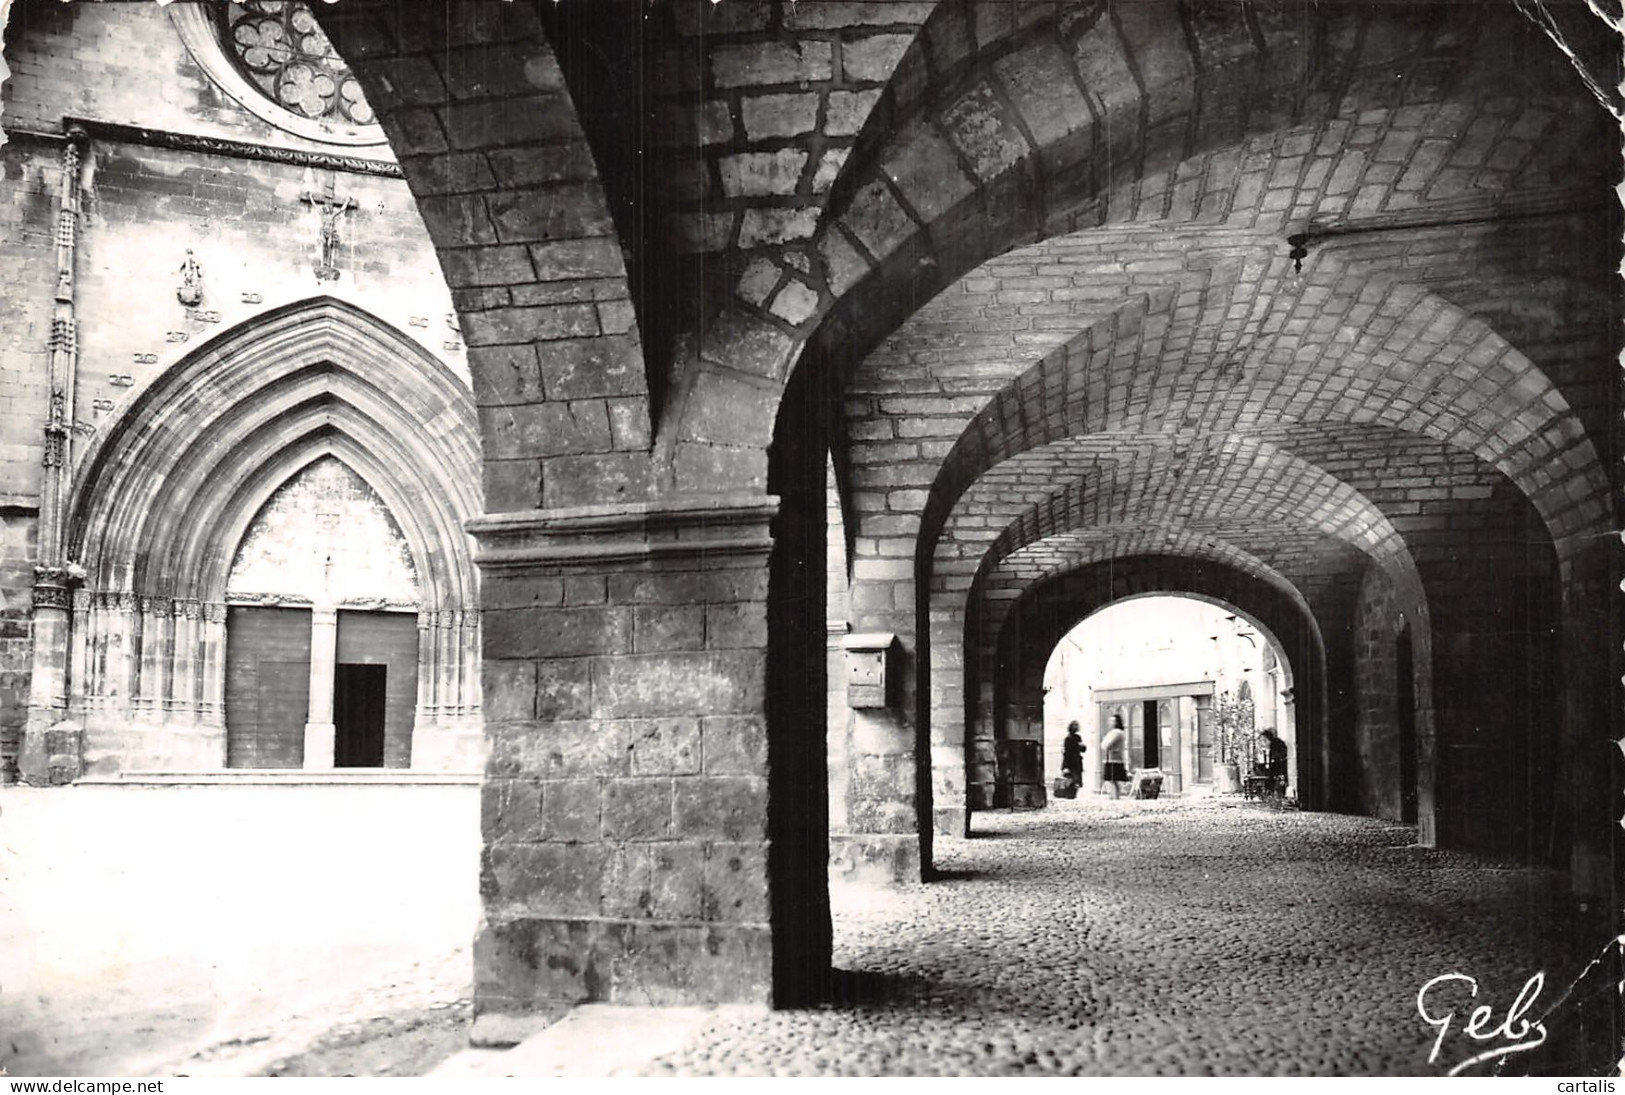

{"left": 70, "top": 297, "right": 481, "bottom": 609}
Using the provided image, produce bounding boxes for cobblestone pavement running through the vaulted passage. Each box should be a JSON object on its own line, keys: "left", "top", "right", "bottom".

{"left": 652, "top": 799, "right": 1606, "bottom": 1076}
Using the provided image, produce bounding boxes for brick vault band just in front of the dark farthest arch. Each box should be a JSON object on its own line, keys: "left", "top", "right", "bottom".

{"left": 928, "top": 434, "right": 1427, "bottom": 814}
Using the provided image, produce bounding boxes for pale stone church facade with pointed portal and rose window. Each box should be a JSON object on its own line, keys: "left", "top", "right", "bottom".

{"left": 0, "top": 3, "right": 481, "bottom": 783}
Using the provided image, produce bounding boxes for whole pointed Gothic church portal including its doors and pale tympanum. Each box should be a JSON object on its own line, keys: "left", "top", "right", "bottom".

{"left": 58, "top": 297, "right": 483, "bottom": 773}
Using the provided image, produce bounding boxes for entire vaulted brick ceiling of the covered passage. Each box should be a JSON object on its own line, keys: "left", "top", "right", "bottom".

{"left": 843, "top": 2, "right": 1612, "bottom": 656}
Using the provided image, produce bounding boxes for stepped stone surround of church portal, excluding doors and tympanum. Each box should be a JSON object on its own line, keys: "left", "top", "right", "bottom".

{"left": 65, "top": 297, "right": 481, "bottom": 770}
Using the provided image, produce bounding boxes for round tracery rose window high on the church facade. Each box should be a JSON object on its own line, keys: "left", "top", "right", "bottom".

{"left": 216, "top": 0, "right": 375, "bottom": 125}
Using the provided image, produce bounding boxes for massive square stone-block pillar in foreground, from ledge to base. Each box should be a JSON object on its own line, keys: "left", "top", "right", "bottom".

{"left": 470, "top": 496, "right": 829, "bottom": 1043}
